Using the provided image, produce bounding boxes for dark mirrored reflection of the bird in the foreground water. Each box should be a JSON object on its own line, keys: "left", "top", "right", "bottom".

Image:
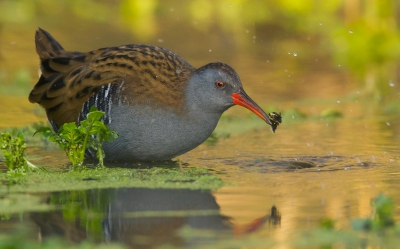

{"left": 25, "top": 188, "right": 281, "bottom": 248}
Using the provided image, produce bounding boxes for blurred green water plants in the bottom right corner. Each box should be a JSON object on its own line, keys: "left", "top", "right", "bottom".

{"left": 293, "top": 194, "right": 400, "bottom": 248}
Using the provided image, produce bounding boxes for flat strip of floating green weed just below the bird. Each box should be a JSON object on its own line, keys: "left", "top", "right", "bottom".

{"left": 0, "top": 167, "right": 223, "bottom": 195}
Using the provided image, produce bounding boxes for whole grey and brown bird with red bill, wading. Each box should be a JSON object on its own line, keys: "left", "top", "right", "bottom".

{"left": 29, "top": 29, "right": 280, "bottom": 162}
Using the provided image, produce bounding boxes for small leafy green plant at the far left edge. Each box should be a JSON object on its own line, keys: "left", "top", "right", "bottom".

{"left": 0, "top": 132, "right": 37, "bottom": 174}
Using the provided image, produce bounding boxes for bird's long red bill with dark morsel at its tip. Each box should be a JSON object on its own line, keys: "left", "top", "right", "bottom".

{"left": 231, "top": 89, "right": 282, "bottom": 132}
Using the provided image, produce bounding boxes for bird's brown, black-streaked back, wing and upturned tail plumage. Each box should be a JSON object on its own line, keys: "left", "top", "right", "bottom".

{"left": 29, "top": 29, "right": 195, "bottom": 126}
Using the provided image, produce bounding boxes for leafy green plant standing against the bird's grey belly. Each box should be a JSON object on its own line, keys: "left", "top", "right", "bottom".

{"left": 34, "top": 106, "right": 118, "bottom": 168}
